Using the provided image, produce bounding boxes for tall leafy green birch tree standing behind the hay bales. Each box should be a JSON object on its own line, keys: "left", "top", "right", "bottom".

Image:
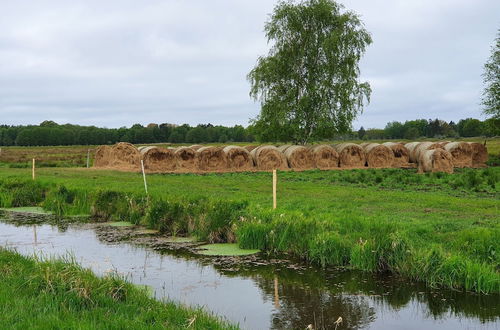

{"left": 248, "top": 0, "right": 372, "bottom": 143}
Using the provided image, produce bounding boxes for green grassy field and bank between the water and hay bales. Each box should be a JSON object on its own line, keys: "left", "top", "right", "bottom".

{"left": 0, "top": 168, "right": 500, "bottom": 293}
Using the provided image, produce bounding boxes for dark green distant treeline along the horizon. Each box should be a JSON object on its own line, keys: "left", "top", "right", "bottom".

{"left": 0, "top": 118, "right": 500, "bottom": 146}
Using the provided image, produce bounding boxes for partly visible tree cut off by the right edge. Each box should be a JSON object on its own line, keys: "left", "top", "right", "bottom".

{"left": 482, "top": 30, "right": 500, "bottom": 119}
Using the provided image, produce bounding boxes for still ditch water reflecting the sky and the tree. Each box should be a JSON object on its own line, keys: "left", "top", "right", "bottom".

{"left": 0, "top": 222, "right": 500, "bottom": 329}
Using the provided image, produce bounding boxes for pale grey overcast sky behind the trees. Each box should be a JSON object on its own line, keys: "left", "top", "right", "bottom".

{"left": 0, "top": 0, "right": 500, "bottom": 129}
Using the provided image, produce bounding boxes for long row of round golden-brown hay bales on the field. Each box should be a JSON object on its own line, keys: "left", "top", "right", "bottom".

{"left": 94, "top": 142, "right": 488, "bottom": 173}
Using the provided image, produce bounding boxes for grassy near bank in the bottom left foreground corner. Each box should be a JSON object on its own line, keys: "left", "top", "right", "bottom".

{"left": 0, "top": 248, "right": 236, "bottom": 329}
